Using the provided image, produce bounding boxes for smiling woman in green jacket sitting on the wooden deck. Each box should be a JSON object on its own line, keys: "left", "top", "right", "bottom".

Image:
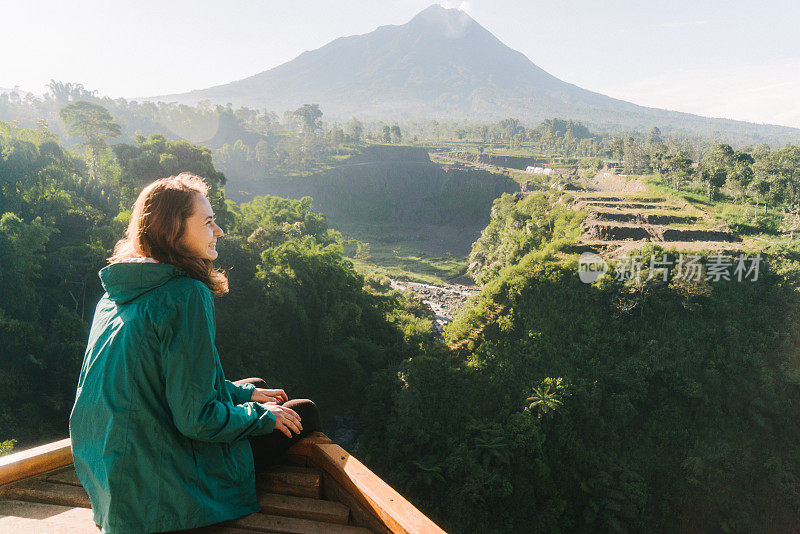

{"left": 69, "top": 173, "right": 321, "bottom": 534}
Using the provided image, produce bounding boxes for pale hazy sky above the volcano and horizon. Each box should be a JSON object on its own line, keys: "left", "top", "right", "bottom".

{"left": 6, "top": 0, "right": 800, "bottom": 127}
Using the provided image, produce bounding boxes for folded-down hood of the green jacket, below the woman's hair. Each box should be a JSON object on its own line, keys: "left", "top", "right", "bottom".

{"left": 97, "top": 262, "right": 187, "bottom": 304}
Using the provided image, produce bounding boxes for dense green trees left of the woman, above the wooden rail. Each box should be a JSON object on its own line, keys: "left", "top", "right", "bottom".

{"left": 0, "top": 123, "right": 113, "bottom": 443}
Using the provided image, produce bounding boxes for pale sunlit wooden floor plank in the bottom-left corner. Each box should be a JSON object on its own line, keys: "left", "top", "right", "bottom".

{"left": 0, "top": 500, "right": 100, "bottom": 534}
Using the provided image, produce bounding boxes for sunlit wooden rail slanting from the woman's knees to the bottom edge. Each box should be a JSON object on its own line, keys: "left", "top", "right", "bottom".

{"left": 312, "top": 444, "right": 444, "bottom": 534}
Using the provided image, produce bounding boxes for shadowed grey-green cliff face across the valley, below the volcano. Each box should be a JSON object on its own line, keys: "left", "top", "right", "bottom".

{"left": 219, "top": 146, "right": 519, "bottom": 255}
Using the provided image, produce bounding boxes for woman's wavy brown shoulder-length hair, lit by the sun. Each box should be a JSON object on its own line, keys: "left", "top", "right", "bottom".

{"left": 108, "top": 172, "right": 228, "bottom": 296}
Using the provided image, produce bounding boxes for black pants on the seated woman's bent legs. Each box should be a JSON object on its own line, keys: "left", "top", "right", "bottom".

{"left": 231, "top": 378, "right": 322, "bottom": 472}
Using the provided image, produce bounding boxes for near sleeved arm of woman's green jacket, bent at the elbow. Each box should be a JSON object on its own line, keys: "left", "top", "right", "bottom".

{"left": 160, "top": 284, "right": 275, "bottom": 442}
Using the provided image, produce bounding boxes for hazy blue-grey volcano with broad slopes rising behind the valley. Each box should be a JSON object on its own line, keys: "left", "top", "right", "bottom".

{"left": 151, "top": 5, "right": 800, "bottom": 140}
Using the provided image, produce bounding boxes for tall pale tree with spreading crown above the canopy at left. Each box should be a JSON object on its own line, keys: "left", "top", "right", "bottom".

{"left": 60, "top": 100, "right": 122, "bottom": 181}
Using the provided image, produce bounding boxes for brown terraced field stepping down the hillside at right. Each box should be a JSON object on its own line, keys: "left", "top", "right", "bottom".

{"left": 571, "top": 192, "right": 745, "bottom": 258}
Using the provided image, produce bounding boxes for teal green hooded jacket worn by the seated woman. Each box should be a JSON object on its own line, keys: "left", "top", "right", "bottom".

{"left": 69, "top": 262, "right": 275, "bottom": 534}
